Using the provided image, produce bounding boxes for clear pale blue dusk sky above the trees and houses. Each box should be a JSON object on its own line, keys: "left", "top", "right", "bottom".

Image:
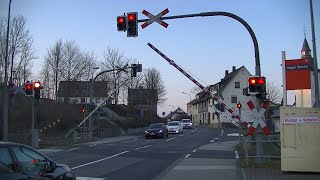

{"left": 0, "top": 0, "right": 320, "bottom": 114}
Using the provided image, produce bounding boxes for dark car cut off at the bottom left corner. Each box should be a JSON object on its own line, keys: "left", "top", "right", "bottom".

{"left": 0, "top": 142, "right": 76, "bottom": 180}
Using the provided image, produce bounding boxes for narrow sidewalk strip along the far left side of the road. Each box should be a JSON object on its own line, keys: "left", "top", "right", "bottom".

{"left": 38, "top": 136, "right": 139, "bottom": 155}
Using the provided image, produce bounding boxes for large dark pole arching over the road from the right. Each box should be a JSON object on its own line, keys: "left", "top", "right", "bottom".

{"left": 138, "top": 12, "right": 264, "bottom": 163}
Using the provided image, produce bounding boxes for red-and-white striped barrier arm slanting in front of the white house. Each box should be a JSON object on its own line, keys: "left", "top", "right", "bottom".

{"left": 148, "top": 43, "right": 251, "bottom": 128}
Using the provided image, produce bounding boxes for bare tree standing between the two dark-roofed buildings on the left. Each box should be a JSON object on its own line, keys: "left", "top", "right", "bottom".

{"left": 101, "top": 47, "right": 129, "bottom": 104}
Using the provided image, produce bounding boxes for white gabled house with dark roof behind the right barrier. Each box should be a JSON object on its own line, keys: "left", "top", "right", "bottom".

{"left": 191, "top": 66, "right": 257, "bottom": 126}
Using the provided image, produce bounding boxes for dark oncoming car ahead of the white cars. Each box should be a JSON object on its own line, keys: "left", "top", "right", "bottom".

{"left": 144, "top": 123, "right": 169, "bottom": 139}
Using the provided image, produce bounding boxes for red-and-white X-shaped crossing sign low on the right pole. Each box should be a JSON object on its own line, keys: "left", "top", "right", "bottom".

{"left": 247, "top": 101, "right": 270, "bottom": 135}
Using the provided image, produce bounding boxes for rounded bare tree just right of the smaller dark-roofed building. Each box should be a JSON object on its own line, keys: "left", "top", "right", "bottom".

{"left": 143, "top": 68, "right": 167, "bottom": 105}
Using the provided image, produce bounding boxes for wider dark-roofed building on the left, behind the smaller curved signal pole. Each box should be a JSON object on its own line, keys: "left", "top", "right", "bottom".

{"left": 58, "top": 81, "right": 112, "bottom": 105}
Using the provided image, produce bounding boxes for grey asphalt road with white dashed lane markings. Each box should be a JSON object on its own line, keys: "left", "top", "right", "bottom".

{"left": 48, "top": 127, "right": 236, "bottom": 180}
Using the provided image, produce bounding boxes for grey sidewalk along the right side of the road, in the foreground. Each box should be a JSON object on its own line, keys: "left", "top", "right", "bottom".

{"left": 157, "top": 141, "right": 238, "bottom": 180}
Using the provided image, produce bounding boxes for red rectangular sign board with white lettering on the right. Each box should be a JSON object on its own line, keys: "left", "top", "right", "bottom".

{"left": 285, "top": 59, "right": 311, "bottom": 90}
